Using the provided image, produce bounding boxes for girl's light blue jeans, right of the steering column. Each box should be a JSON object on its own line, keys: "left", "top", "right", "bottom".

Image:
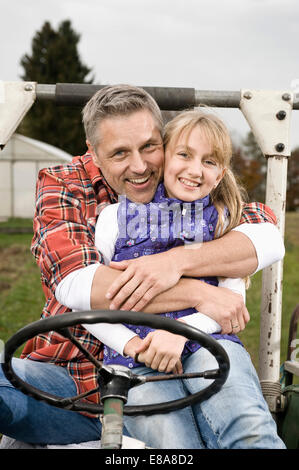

{"left": 124, "top": 340, "right": 285, "bottom": 449}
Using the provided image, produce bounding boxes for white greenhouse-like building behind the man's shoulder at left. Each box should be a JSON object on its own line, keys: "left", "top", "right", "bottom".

{"left": 0, "top": 134, "right": 72, "bottom": 218}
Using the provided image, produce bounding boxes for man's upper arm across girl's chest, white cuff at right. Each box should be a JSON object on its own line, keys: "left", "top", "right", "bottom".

{"left": 108, "top": 203, "right": 284, "bottom": 310}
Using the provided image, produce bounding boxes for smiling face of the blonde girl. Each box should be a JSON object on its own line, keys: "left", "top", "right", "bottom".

{"left": 164, "top": 125, "right": 225, "bottom": 202}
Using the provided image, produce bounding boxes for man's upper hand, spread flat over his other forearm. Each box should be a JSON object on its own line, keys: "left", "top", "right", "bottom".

{"left": 106, "top": 252, "right": 181, "bottom": 311}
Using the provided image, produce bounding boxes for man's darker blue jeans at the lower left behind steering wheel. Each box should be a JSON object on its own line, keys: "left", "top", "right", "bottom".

{"left": 0, "top": 359, "right": 102, "bottom": 445}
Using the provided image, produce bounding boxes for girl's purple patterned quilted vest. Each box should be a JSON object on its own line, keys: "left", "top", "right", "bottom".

{"left": 104, "top": 183, "right": 241, "bottom": 368}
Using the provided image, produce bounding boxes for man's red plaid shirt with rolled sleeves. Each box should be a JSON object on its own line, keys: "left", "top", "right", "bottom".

{"left": 21, "top": 153, "right": 276, "bottom": 414}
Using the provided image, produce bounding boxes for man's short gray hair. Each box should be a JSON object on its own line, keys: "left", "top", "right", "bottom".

{"left": 82, "top": 85, "right": 163, "bottom": 149}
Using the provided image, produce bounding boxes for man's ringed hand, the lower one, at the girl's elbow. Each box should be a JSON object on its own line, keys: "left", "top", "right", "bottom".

{"left": 195, "top": 284, "right": 250, "bottom": 334}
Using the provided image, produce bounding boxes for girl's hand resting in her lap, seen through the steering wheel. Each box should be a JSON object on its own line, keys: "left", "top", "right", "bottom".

{"left": 132, "top": 330, "right": 187, "bottom": 374}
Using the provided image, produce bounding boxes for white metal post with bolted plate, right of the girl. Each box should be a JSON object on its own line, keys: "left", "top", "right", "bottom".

{"left": 240, "top": 90, "right": 293, "bottom": 413}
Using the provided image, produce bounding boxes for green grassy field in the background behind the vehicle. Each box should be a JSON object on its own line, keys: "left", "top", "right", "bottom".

{"left": 0, "top": 213, "right": 299, "bottom": 374}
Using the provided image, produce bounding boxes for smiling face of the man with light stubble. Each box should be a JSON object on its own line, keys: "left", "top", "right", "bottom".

{"left": 87, "top": 110, "right": 164, "bottom": 203}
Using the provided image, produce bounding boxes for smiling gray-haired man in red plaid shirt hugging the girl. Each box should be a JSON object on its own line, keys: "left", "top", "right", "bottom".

{"left": 0, "top": 85, "right": 284, "bottom": 447}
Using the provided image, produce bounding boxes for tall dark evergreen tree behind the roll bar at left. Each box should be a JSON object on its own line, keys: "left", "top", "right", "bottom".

{"left": 19, "top": 20, "right": 93, "bottom": 155}
